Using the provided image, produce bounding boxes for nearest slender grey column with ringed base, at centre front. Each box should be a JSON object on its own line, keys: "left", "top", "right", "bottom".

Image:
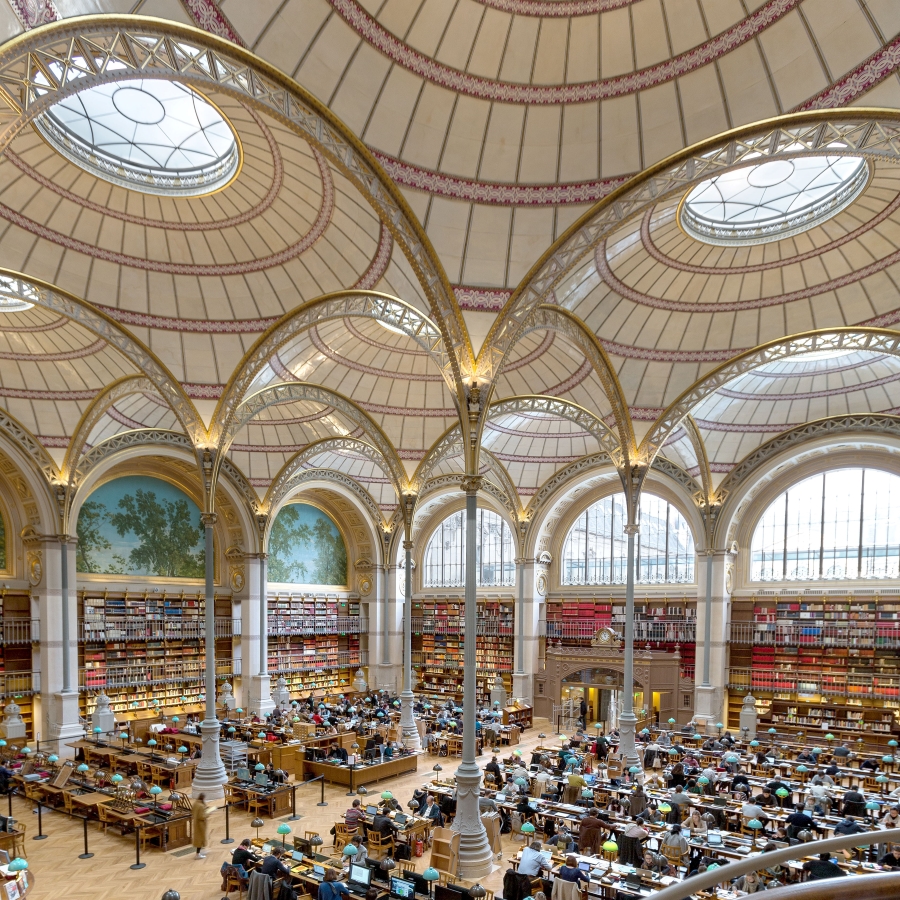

{"left": 453, "top": 478, "right": 493, "bottom": 879}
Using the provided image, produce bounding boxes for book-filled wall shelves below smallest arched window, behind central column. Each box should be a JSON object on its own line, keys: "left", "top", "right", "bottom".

{"left": 412, "top": 598, "right": 515, "bottom": 706}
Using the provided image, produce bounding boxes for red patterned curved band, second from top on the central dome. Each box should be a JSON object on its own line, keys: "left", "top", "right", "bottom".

{"left": 327, "top": 0, "right": 801, "bottom": 106}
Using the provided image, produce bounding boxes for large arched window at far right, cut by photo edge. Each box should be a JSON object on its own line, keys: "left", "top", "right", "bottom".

{"left": 750, "top": 468, "right": 900, "bottom": 581}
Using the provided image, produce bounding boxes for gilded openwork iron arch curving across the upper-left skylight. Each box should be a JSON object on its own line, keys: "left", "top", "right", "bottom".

{"left": 0, "top": 15, "right": 474, "bottom": 404}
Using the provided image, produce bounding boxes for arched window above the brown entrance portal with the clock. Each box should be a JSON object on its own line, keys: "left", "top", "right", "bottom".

{"left": 562, "top": 494, "right": 694, "bottom": 584}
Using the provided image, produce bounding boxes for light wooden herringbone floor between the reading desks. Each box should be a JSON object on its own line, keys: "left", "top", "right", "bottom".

{"left": 21, "top": 719, "right": 550, "bottom": 900}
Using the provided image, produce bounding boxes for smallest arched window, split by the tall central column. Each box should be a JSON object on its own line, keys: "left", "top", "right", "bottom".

{"left": 420, "top": 509, "right": 516, "bottom": 590}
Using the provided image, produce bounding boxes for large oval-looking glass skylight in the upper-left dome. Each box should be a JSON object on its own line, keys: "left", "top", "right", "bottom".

{"left": 35, "top": 78, "right": 240, "bottom": 197}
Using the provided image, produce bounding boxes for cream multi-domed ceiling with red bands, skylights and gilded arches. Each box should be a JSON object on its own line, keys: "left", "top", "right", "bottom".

{"left": 0, "top": 0, "right": 900, "bottom": 532}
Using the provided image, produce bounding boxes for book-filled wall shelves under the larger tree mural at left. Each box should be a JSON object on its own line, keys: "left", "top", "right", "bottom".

{"left": 78, "top": 591, "right": 233, "bottom": 719}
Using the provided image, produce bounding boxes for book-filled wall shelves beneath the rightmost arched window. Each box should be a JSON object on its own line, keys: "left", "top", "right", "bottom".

{"left": 728, "top": 590, "right": 900, "bottom": 743}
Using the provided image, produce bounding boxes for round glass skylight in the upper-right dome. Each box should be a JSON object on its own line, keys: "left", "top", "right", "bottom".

{"left": 680, "top": 156, "right": 869, "bottom": 245}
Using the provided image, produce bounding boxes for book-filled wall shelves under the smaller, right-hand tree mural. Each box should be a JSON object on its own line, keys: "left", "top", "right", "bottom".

{"left": 268, "top": 594, "right": 363, "bottom": 697}
